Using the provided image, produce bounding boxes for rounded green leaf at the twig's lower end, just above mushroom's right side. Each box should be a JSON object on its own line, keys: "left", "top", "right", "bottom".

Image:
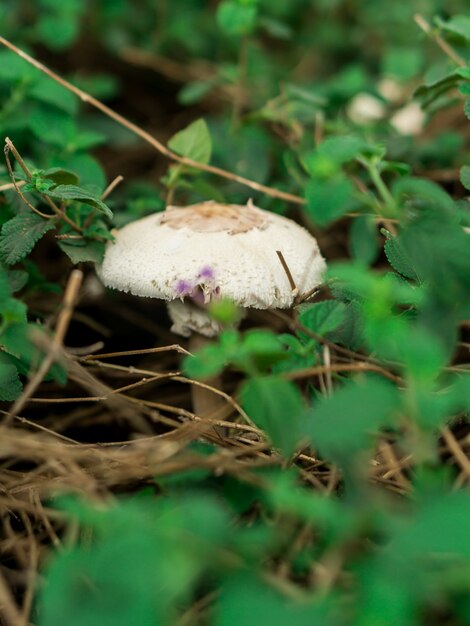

{"left": 305, "top": 175, "right": 355, "bottom": 226}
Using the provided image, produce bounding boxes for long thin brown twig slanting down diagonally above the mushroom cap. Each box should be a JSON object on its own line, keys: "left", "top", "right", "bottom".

{"left": 0, "top": 37, "right": 305, "bottom": 204}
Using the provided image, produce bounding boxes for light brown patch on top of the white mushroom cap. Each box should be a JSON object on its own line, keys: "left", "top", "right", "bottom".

{"left": 160, "top": 201, "right": 267, "bottom": 235}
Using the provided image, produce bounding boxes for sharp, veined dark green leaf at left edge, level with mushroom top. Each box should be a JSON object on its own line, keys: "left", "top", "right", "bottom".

{"left": 0, "top": 211, "right": 55, "bottom": 265}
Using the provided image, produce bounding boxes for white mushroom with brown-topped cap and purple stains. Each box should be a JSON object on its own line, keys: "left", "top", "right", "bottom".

{"left": 98, "top": 201, "right": 325, "bottom": 424}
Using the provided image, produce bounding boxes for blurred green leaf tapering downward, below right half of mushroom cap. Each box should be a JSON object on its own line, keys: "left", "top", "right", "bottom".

{"left": 240, "top": 376, "right": 305, "bottom": 456}
